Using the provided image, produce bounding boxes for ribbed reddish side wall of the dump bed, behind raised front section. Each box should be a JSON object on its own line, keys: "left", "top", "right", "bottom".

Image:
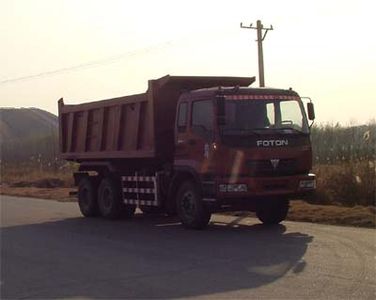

{"left": 59, "top": 94, "right": 155, "bottom": 160}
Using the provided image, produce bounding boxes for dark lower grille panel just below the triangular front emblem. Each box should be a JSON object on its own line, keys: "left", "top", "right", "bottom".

{"left": 246, "top": 159, "right": 297, "bottom": 176}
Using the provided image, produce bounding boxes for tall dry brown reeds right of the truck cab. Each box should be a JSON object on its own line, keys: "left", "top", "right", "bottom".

{"left": 310, "top": 121, "right": 376, "bottom": 206}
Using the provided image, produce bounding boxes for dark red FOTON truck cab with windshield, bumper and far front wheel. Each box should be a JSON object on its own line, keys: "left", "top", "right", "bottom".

{"left": 174, "top": 87, "right": 316, "bottom": 227}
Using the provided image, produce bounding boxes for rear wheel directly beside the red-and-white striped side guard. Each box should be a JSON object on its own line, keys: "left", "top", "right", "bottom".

{"left": 98, "top": 177, "right": 136, "bottom": 220}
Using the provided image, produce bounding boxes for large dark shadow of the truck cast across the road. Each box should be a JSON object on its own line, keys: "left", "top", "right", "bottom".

{"left": 1, "top": 215, "right": 313, "bottom": 298}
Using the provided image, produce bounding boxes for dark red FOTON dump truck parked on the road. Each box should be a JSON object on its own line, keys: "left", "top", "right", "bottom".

{"left": 58, "top": 75, "right": 316, "bottom": 229}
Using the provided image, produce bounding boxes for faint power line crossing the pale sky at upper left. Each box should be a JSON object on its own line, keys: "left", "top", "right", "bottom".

{"left": 0, "top": 41, "right": 172, "bottom": 85}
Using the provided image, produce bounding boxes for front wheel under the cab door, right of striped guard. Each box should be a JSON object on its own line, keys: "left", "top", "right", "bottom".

{"left": 176, "top": 181, "right": 211, "bottom": 229}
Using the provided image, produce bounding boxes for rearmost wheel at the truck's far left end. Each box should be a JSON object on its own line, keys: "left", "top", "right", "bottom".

{"left": 78, "top": 177, "right": 99, "bottom": 217}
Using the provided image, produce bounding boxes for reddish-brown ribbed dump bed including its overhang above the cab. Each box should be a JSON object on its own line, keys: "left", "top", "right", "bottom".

{"left": 59, "top": 75, "right": 254, "bottom": 161}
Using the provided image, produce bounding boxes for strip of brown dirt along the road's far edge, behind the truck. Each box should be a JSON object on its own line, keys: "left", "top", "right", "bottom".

{"left": 0, "top": 185, "right": 376, "bottom": 228}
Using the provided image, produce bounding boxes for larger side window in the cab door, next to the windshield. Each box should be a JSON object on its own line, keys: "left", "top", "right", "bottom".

{"left": 192, "top": 100, "right": 214, "bottom": 137}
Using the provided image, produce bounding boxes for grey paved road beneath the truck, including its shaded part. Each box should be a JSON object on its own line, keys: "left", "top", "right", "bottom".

{"left": 1, "top": 196, "right": 376, "bottom": 299}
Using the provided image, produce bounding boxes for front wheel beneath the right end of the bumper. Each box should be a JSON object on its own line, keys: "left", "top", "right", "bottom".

{"left": 256, "top": 199, "right": 289, "bottom": 225}
